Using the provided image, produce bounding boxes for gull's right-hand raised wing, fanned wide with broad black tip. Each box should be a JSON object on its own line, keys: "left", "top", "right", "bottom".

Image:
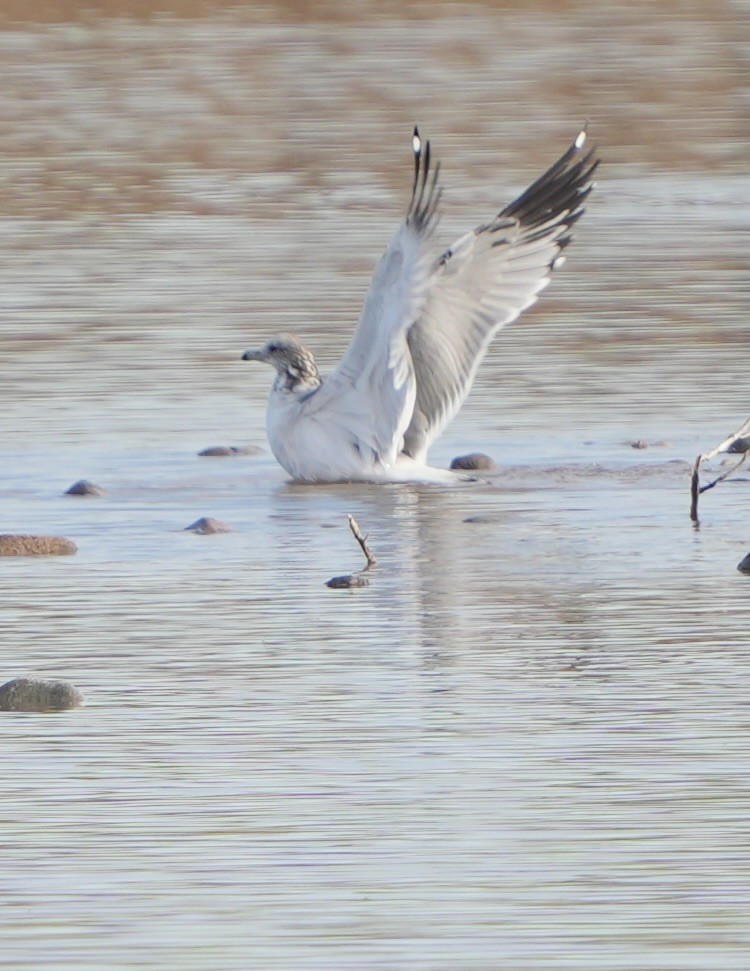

{"left": 404, "top": 130, "right": 598, "bottom": 461}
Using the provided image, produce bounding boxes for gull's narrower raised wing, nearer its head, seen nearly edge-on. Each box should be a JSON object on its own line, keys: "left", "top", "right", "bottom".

{"left": 308, "top": 128, "right": 441, "bottom": 464}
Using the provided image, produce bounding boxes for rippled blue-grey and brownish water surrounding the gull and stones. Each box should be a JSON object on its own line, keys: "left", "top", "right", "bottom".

{"left": 0, "top": 2, "right": 750, "bottom": 971}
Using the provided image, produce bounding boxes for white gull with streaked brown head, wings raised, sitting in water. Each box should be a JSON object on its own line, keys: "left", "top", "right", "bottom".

{"left": 243, "top": 128, "right": 598, "bottom": 482}
